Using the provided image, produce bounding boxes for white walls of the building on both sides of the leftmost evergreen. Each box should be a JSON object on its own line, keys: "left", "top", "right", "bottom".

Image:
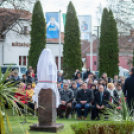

{"left": 0, "top": 21, "right": 63, "bottom": 65}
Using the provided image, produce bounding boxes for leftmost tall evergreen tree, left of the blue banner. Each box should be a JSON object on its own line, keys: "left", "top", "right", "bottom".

{"left": 28, "top": 1, "right": 46, "bottom": 69}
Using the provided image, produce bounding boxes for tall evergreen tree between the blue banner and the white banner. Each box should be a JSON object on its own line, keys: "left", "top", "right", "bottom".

{"left": 63, "top": 2, "right": 82, "bottom": 79}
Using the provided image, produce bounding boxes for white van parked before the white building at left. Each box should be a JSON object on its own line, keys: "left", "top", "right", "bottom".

{"left": 0, "top": 65, "right": 27, "bottom": 78}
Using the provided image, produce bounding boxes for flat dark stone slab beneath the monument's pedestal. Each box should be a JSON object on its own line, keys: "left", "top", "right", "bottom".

{"left": 30, "top": 124, "right": 64, "bottom": 133}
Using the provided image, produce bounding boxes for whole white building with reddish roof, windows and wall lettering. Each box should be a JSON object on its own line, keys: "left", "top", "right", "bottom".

{"left": 0, "top": 9, "right": 64, "bottom": 69}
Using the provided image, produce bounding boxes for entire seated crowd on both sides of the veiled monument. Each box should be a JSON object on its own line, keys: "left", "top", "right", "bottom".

{"left": 4, "top": 67, "right": 125, "bottom": 120}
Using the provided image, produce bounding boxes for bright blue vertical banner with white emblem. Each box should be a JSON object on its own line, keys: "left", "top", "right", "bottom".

{"left": 46, "top": 12, "right": 59, "bottom": 39}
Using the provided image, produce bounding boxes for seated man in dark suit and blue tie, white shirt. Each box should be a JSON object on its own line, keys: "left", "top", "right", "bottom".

{"left": 92, "top": 85, "right": 110, "bottom": 120}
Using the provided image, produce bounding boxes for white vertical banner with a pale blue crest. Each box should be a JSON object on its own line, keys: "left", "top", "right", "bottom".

{"left": 78, "top": 15, "right": 91, "bottom": 40}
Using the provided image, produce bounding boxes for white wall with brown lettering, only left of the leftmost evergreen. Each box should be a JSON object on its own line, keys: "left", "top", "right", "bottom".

{"left": 4, "top": 21, "right": 30, "bottom": 65}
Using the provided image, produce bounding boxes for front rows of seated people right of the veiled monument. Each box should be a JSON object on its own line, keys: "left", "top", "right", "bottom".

{"left": 57, "top": 78, "right": 122, "bottom": 120}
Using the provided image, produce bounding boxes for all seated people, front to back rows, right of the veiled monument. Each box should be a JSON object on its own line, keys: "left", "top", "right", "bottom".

{"left": 57, "top": 69, "right": 125, "bottom": 120}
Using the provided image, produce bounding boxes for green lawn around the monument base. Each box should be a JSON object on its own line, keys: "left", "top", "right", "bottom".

{"left": 9, "top": 112, "right": 90, "bottom": 134}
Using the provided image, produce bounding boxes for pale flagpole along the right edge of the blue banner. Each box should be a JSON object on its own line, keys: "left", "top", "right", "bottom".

{"left": 58, "top": 10, "right": 61, "bottom": 71}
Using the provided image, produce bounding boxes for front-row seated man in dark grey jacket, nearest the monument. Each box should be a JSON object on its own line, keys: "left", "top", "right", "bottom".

{"left": 57, "top": 83, "right": 73, "bottom": 119}
